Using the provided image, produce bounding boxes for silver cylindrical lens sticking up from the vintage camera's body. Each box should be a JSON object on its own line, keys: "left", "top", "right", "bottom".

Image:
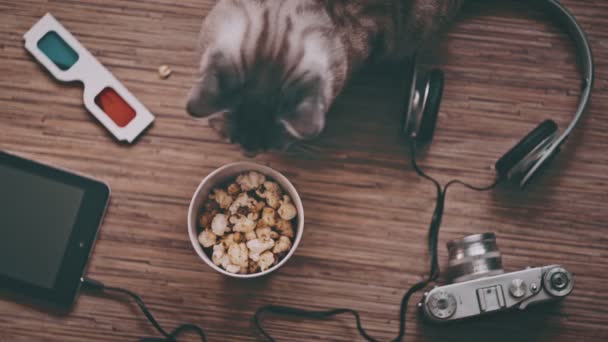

{"left": 447, "top": 233, "right": 504, "bottom": 283}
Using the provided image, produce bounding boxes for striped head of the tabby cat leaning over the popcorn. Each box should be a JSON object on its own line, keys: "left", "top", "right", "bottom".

{"left": 187, "top": 2, "right": 339, "bottom": 154}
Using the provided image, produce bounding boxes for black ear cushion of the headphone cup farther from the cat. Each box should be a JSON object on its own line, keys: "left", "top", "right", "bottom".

{"left": 495, "top": 120, "right": 558, "bottom": 177}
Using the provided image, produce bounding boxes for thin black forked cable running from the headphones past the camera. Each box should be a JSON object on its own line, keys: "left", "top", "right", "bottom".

{"left": 253, "top": 140, "right": 500, "bottom": 342}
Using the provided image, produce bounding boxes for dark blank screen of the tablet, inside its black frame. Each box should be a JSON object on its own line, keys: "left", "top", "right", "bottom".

{"left": 0, "top": 164, "right": 84, "bottom": 289}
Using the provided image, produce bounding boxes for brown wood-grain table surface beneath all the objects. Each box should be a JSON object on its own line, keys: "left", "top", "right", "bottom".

{"left": 0, "top": 0, "right": 608, "bottom": 341}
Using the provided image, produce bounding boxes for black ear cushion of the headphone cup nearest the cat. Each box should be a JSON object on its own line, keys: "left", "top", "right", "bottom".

{"left": 416, "top": 69, "right": 445, "bottom": 144}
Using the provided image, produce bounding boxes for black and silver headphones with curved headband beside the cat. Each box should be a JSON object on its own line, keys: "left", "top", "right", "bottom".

{"left": 403, "top": 0, "right": 595, "bottom": 188}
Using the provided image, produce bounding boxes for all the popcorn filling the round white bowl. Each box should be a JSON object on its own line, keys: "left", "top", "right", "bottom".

{"left": 198, "top": 172, "right": 298, "bottom": 274}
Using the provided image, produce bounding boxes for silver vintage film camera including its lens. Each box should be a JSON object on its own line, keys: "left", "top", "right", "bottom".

{"left": 418, "top": 233, "right": 574, "bottom": 323}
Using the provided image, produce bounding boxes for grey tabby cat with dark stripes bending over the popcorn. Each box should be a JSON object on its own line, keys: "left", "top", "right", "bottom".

{"left": 187, "top": 0, "right": 464, "bottom": 154}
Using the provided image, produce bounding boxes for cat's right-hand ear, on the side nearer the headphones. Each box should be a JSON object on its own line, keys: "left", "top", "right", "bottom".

{"left": 281, "top": 77, "right": 328, "bottom": 140}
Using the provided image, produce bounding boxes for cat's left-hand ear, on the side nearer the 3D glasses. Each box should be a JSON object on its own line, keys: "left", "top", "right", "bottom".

{"left": 186, "top": 52, "right": 240, "bottom": 117}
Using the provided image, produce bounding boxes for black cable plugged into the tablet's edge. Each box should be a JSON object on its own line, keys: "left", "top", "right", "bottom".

{"left": 82, "top": 277, "right": 207, "bottom": 342}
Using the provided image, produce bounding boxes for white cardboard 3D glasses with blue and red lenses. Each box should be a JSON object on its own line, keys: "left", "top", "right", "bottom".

{"left": 23, "top": 13, "right": 154, "bottom": 143}
